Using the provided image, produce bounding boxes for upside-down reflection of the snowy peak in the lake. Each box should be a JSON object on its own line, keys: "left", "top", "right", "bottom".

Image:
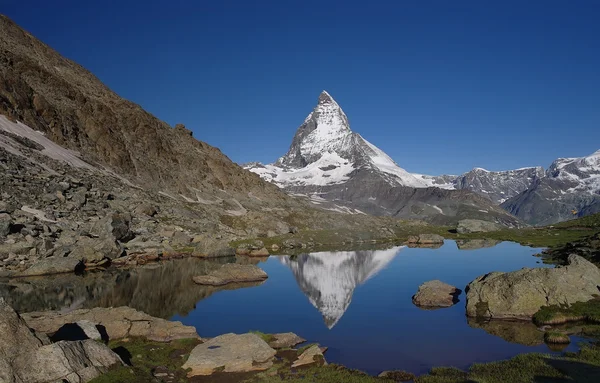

{"left": 280, "top": 247, "right": 403, "bottom": 329}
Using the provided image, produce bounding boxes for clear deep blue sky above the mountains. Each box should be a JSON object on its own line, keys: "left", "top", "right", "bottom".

{"left": 0, "top": 0, "right": 600, "bottom": 174}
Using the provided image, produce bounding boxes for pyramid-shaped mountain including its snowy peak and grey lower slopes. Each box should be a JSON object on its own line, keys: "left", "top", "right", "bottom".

{"left": 245, "top": 91, "right": 517, "bottom": 225}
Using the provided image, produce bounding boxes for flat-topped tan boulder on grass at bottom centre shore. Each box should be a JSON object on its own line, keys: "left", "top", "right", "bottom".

{"left": 182, "top": 334, "right": 276, "bottom": 377}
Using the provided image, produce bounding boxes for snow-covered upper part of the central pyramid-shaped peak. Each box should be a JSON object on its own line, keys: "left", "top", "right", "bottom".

{"left": 248, "top": 91, "right": 428, "bottom": 187}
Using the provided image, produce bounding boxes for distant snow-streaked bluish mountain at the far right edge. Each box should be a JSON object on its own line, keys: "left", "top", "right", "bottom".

{"left": 502, "top": 150, "right": 600, "bottom": 225}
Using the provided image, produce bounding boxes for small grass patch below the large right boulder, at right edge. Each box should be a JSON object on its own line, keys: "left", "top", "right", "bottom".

{"left": 533, "top": 298, "right": 600, "bottom": 325}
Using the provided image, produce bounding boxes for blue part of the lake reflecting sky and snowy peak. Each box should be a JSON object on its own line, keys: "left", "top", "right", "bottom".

{"left": 174, "top": 241, "right": 576, "bottom": 373}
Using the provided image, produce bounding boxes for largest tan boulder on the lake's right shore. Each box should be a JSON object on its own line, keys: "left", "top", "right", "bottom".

{"left": 466, "top": 254, "right": 600, "bottom": 320}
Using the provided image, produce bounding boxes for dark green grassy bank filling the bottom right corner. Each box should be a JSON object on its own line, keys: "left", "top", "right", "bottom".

{"left": 415, "top": 345, "right": 600, "bottom": 383}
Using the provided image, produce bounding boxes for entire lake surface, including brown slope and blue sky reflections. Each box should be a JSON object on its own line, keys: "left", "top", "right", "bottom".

{"left": 0, "top": 241, "right": 578, "bottom": 374}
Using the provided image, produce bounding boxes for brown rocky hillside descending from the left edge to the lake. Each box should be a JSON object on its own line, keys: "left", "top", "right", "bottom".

{"left": 0, "top": 15, "right": 446, "bottom": 276}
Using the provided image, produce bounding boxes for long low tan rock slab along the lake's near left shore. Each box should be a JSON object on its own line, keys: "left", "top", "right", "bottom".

{"left": 23, "top": 306, "right": 199, "bottom": 342}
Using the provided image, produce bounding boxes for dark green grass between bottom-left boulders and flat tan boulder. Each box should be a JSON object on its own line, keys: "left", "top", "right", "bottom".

{"left": 91, "top": 338, "right": 200, "bottom": 383}
